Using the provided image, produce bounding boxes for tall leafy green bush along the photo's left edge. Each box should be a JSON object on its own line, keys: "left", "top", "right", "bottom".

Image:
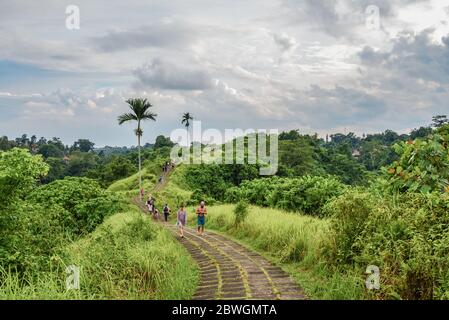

{"left": 0, "top": 148, "right": 63, "bottom": 272}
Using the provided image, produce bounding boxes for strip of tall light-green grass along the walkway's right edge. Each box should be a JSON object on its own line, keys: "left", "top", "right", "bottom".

{"left": 198, "top": 205, "right": 364, "bottom": 299}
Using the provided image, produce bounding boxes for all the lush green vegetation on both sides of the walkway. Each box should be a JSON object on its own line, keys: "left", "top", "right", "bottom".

{"left": 0, "top": 110, "right": 449, "bottom": 299}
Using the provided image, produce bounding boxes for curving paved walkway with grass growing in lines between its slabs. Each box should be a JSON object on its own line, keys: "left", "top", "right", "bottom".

{"left": 164, "top": 223, "right": 305, "bottom": 300}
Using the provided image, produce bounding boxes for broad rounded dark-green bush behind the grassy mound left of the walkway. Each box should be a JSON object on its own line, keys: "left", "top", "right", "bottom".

{"left": 0, "top": 178, "right": 123, "bottom": 273}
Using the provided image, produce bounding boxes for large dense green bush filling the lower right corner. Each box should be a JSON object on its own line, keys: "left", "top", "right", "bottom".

{"left": 325, "top": 191, "right": 449, "bottom": 299}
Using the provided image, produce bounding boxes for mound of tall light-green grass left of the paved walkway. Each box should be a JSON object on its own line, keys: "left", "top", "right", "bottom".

{"left": 0, "top": 209, "right": 198, "bottom": 300}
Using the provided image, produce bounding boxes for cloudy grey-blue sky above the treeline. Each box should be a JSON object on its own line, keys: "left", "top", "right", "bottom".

{"left": 0, "top": 0, "right": 449, "bottom": 146}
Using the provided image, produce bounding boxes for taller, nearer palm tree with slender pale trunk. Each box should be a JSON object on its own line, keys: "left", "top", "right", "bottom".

{"left": 118, "top": 99, "right": 157, "bottom": 200}
